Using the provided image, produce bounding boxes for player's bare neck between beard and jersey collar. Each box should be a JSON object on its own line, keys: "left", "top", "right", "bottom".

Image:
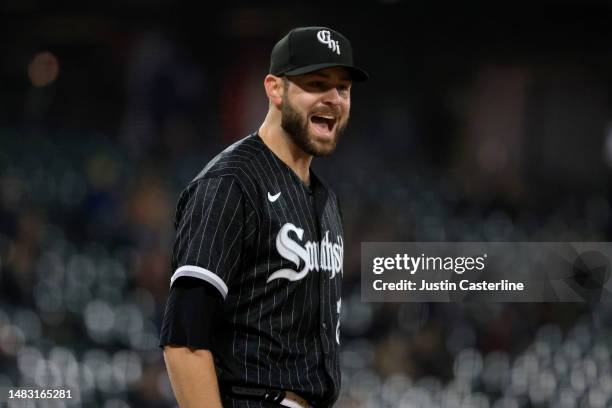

{"left": 259, "top": 112, "right": 312, "bottom": 185}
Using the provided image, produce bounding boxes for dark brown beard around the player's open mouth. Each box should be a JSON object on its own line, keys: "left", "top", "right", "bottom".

{"left": 281, "top": 93, "right": 348, "bottom": 157}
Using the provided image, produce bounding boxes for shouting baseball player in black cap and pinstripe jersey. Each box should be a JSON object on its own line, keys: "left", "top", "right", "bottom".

{"left": 161, "top": 27, "right": 367, "bottom": 408}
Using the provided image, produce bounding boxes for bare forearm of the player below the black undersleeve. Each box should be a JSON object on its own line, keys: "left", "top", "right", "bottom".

{"left": 164, "top": 345, "right": 222, "bottom": 408}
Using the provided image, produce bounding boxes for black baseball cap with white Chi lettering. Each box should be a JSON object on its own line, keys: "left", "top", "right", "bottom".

{"left": 270, "top": 27, "right": 368, "bottom": 82}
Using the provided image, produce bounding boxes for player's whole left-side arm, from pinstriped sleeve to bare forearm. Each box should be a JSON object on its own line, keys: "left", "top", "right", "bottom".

{"left": 160, "top": 177, "right": 251, "bottom": 408}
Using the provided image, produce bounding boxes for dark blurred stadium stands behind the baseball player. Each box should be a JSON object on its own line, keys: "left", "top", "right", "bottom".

{"left": 0, "top": 0, "right": 612, "bottom": 408}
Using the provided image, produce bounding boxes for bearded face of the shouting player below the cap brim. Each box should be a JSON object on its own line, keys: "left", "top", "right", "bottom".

{"left": 281, "top": 67, "right": 351, "bottom": 156}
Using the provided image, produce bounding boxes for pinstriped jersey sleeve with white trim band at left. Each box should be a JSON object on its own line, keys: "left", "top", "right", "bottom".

{"left": 170, "top": 176, "right": 245, "bottom": 299}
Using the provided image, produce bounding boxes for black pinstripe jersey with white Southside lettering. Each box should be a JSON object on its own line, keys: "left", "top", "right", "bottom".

{"left": 171, "top": 134, "right": 344, "bottom": 407}
